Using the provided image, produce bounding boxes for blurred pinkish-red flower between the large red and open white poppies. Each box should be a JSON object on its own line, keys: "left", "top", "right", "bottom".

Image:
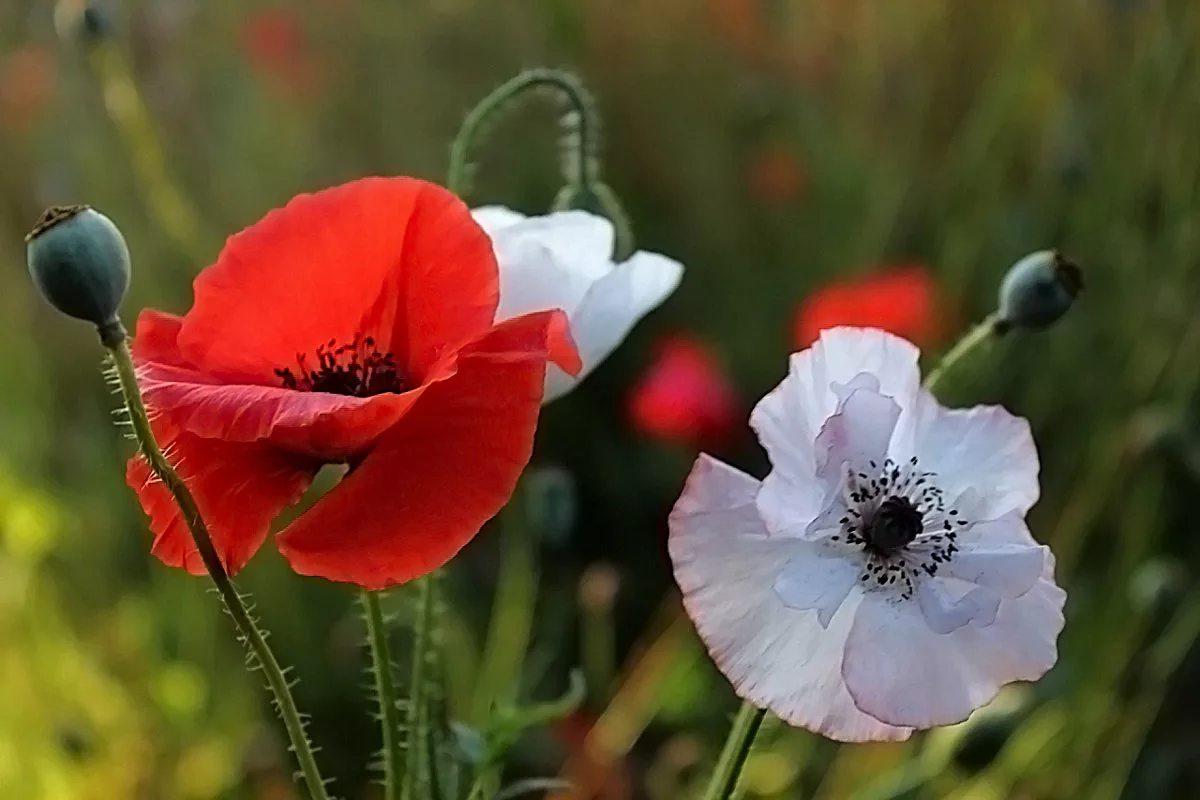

{"left": 629, "top": 336, "right": 738, "bottom": 446}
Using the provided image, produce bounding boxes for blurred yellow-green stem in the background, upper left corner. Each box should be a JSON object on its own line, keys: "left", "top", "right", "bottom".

{"left": 89, "top": 41, "right": 211, "bottom": 264}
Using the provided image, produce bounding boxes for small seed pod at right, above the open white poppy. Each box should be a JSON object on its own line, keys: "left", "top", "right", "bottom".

{"left": 996, "top": 249, "right": 1084, "bottom": 333}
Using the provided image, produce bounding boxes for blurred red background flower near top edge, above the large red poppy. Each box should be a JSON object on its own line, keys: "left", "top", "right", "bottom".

{"left": 241, "top": 8, "right": 322, "bottom": 100}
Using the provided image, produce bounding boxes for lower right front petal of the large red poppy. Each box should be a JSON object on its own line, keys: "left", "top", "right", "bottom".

{"left": 278, "top": 312, "right": 562, "bottom": 589}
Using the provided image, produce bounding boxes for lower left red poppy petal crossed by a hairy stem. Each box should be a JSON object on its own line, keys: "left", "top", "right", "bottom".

{"left": 126, "top": 421, "right": 319, "bottom": 575}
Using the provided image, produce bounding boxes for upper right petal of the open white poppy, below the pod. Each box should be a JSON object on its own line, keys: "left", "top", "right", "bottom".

{"left": 893, "top": 390, "right": 1038, "bottom": 519}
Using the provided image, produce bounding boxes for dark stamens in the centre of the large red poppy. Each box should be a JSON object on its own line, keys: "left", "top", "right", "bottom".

{"left": 275, "top": 336, "right": 407, "bottom": 397}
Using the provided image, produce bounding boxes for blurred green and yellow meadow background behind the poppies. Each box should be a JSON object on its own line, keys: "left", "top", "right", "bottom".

{"left": 0, "top": 0, "right": 1200, "bottom": 800}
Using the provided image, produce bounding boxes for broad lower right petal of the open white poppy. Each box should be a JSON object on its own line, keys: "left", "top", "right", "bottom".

{"left": 842, "top": 551, "right": 1066, "bottom": 728}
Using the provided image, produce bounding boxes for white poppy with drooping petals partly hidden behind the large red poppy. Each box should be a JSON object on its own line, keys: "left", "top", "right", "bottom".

{"left": 472, "top": 206, "right": 683, "bottom": 403}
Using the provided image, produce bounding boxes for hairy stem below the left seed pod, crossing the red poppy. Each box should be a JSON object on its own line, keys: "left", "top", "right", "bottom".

{"left": 100, "top": 323, "right": 329, "bottom": 800}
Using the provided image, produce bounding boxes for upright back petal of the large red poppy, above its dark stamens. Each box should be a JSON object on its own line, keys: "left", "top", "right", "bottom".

{"left": 179, "top": 178, "right": 498, "bottom": 383}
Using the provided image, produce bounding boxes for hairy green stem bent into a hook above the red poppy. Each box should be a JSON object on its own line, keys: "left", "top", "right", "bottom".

{"left": 446, "top": 68, "right": 600, "bottom": 197}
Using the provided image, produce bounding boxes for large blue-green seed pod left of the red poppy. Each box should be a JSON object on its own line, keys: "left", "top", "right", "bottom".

{"left": 25, "top": 205, "right": 130, "bottom": 338}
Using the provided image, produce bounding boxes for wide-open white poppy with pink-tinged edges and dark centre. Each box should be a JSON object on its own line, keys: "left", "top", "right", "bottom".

{"left": 670, "top": 327, "right": 1066, "bottom": 741}
